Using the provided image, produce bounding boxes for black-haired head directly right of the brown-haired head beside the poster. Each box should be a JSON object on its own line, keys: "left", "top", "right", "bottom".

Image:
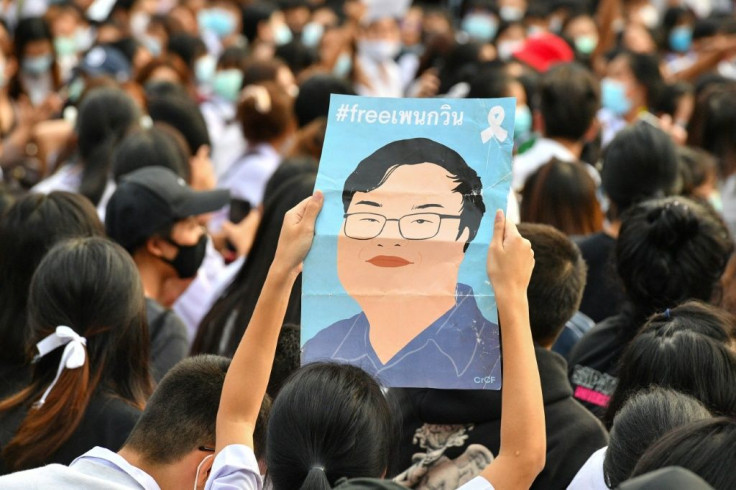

{"left": 601, "top": 122, "right": 677, "bottom": 218}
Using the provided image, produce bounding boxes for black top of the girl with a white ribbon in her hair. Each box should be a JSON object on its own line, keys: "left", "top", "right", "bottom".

{"left": 0, "top": 394, "right": 141, "bottom": 474}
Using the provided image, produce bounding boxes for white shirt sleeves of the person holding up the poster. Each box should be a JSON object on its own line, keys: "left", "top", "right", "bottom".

{"left": 204, "top": 444, "right": 494, "bottom": 490}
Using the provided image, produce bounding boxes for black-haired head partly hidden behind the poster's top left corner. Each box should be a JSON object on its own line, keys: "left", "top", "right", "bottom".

{"left": 294, "top": 73, "right": 355, "bottom": 128}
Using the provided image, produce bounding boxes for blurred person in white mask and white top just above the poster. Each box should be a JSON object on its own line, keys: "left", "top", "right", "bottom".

{"left": 355, "top": 17, "right": 403, "bottom": 97}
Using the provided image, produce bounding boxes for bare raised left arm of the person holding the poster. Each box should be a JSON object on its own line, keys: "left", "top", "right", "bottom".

{"left": 216, "top": 191, "right": 324, "bottom": 453}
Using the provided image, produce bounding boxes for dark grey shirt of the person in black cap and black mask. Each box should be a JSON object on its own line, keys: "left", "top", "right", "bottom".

{"left": 146, "top": 298, "right": 189, "bottom": 383}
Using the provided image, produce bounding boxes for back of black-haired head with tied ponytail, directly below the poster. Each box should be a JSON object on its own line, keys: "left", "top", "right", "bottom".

{"left": 266, "top": 363, "right": 395, "bottom": 490}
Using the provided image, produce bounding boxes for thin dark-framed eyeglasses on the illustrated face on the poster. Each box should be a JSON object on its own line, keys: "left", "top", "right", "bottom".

{"left": 343, "top": 213, "right": 460, "bottom": 240}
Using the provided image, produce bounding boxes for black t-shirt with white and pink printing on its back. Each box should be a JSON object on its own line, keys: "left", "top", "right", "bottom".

{"left": 568, "top": 312, "right": 643, "bottom": 417}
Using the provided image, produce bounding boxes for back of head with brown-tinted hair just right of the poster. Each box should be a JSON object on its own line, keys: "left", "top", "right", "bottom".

{"left": 520, "top": 158, "right": 603, "bottom": 236}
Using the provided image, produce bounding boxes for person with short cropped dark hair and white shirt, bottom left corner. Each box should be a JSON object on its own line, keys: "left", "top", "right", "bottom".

{"left": 0, "top": 355, "right": 270, "bottom": 490}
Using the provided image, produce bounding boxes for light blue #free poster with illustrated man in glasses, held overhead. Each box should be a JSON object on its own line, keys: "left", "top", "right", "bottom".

{"left": 302, "top": 95, "right": 515, "bottom": 389}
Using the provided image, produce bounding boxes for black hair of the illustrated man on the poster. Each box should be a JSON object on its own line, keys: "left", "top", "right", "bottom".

{"left": 342, "top": 138, "right": 486, "bottom": 251}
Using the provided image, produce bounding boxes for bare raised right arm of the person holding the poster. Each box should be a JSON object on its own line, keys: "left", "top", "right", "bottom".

{"left": 481, "top": 210, "right": 547, "bottom": 490}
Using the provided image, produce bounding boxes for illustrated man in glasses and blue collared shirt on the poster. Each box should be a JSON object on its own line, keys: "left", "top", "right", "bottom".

{"left": 302, "top": 138, "right": 500, "bottom": 389}
